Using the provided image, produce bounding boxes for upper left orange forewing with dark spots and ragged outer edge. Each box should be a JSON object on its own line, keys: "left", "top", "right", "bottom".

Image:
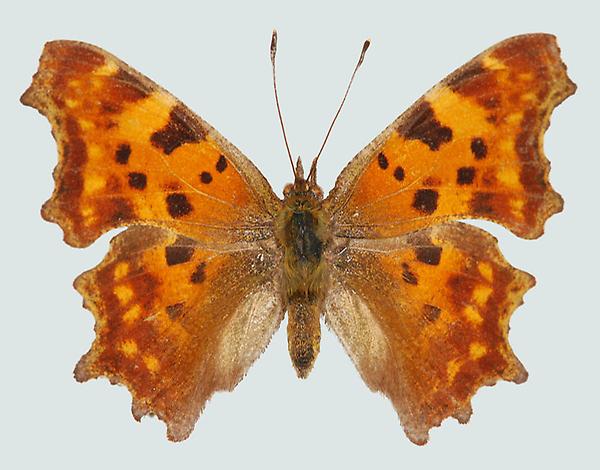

{"left": 21, "top": 41, "right": 280, "bottom": 246}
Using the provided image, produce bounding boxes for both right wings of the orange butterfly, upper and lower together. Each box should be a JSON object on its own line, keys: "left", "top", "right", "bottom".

{"left": 325, "top": 34, "right": 575, "bottom": 444}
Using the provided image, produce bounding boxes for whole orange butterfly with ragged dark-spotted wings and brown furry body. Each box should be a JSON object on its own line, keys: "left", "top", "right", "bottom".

{"left": 21, "top": 34, "right": 576, "bottom": 444}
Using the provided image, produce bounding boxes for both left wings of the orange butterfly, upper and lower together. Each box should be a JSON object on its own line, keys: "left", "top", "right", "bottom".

{"left": 21, "top": 41, "right": 283, "bottom": 440}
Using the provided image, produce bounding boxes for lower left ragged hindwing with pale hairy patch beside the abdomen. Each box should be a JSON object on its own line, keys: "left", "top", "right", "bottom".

{"left": 75, "top": 227, "right": 283, "bottom": 441}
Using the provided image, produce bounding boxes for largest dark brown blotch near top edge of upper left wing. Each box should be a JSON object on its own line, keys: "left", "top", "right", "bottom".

{"left": 150, "top": 105, "right": 205, "bottom": 155}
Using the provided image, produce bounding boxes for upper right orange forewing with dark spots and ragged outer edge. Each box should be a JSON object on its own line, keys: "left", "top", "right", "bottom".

{"left": 325, "top": 34, "right": 575, "bottom": 238}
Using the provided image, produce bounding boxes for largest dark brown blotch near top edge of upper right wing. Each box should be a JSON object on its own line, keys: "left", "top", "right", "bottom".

{"left": 398, "top": 100, "right": 452, "bottom": 150}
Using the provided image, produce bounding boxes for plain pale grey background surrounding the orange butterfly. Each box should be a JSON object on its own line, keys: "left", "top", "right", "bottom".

{"left": 0, "top": 0, "right": 600, "bottom": 470}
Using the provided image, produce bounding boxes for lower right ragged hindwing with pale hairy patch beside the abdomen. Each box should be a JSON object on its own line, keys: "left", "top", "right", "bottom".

{"left": 325, "top": 222, "right": 534, "bottom": 444}
